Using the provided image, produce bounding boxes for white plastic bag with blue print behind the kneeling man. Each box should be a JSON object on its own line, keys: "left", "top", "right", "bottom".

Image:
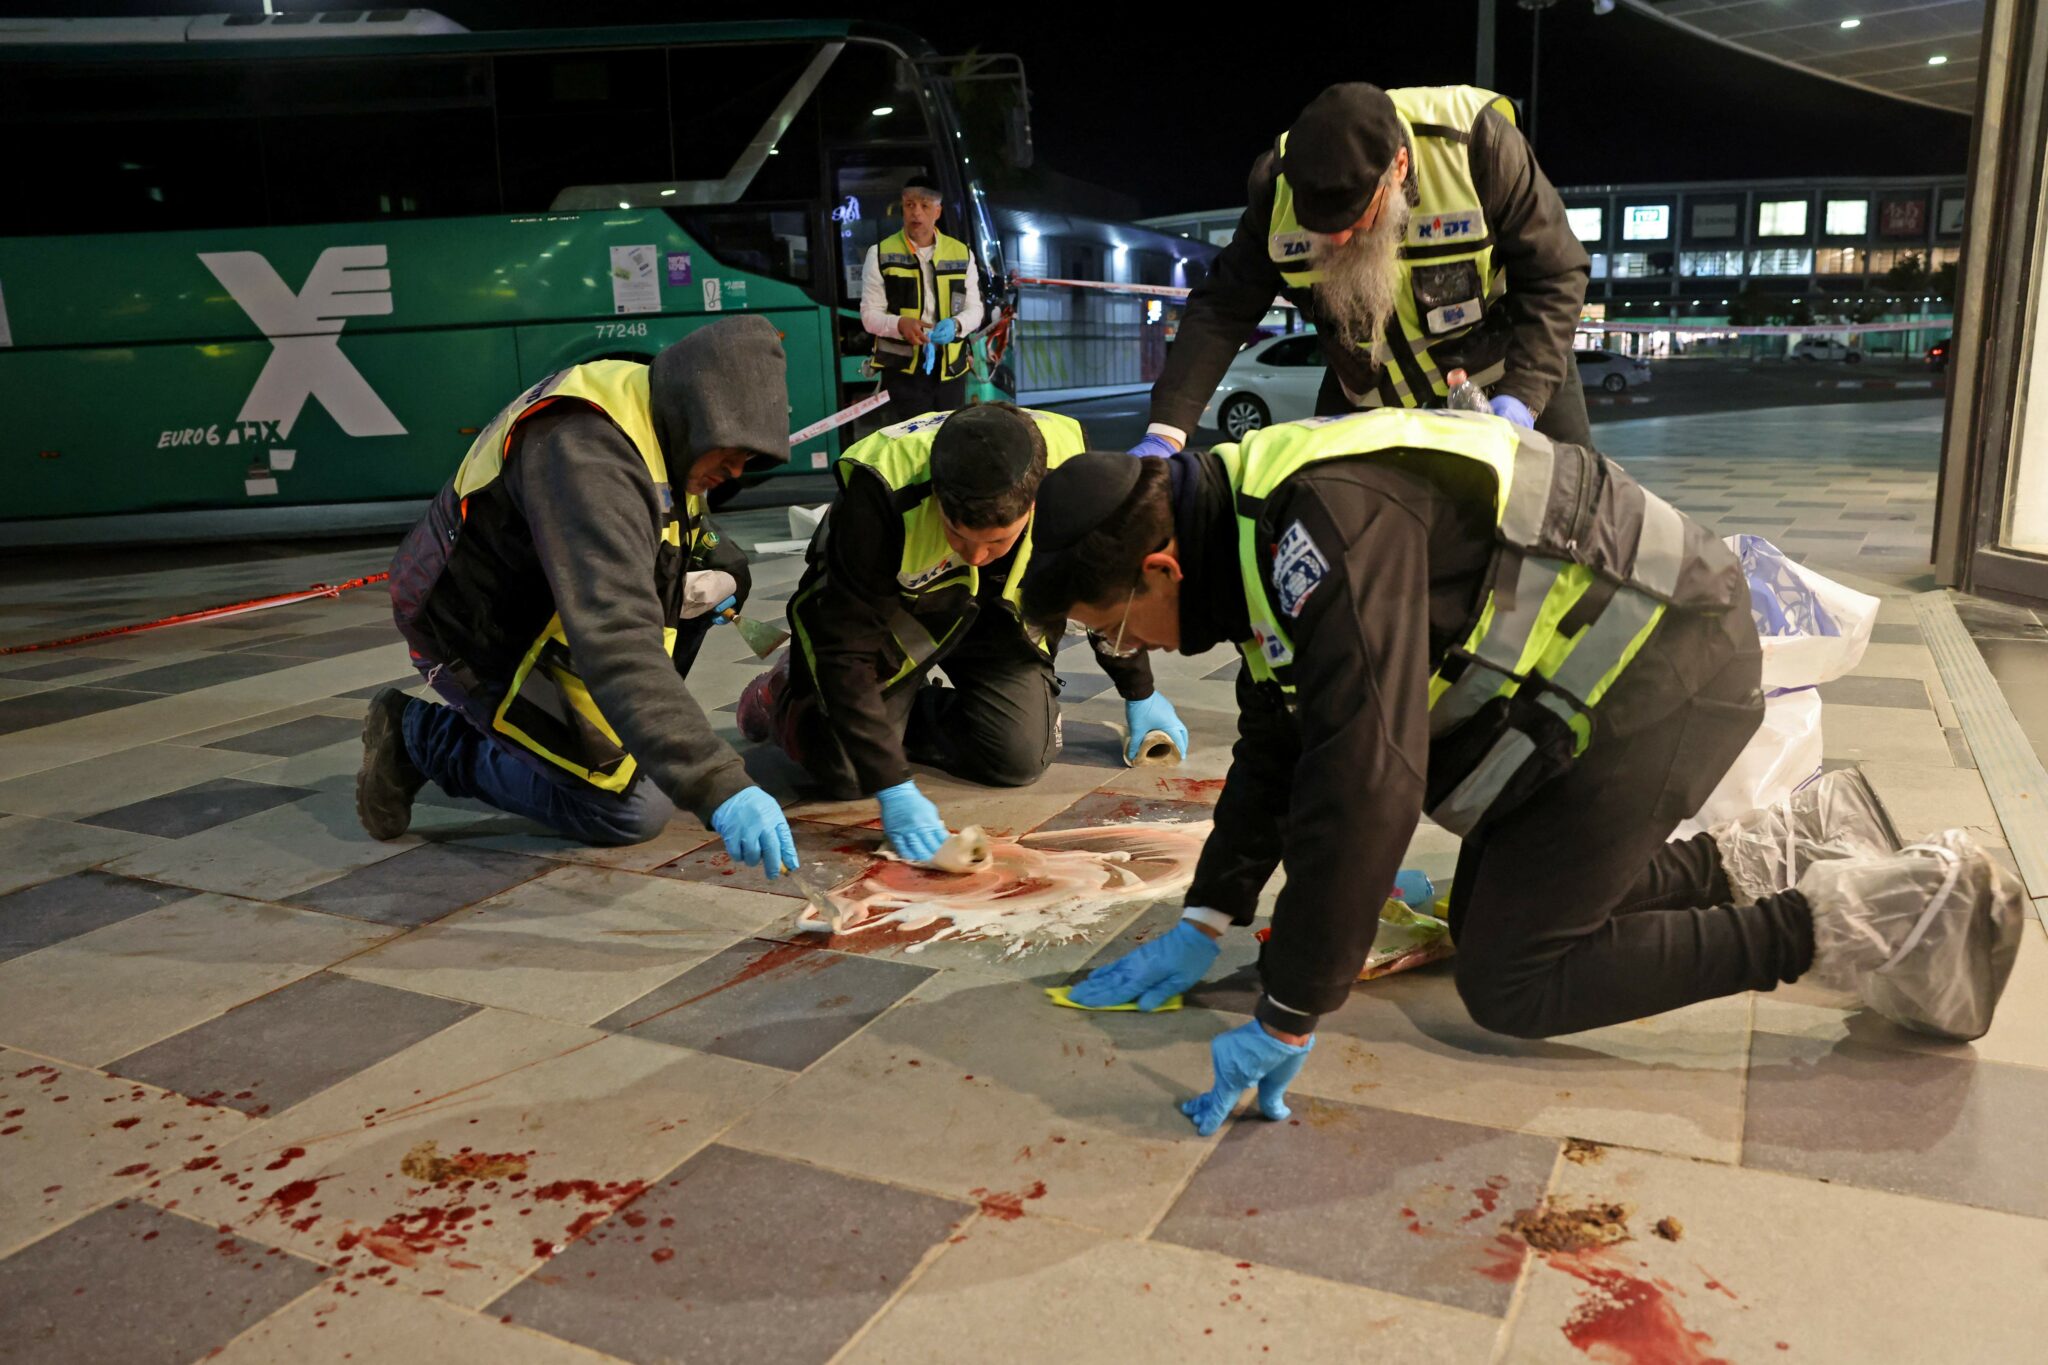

{"left": 1673, "top": 536, "right": 1878, "bottom": 839}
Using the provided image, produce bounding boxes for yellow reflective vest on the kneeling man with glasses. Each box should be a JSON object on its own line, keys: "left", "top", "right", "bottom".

{"left": 1217, "top": 407, "right": 1733, "bottom": 835}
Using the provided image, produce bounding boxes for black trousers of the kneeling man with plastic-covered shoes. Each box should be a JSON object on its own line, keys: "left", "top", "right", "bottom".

{"left": 1450, "top": 641, "right": 1812, "bottom": 1038}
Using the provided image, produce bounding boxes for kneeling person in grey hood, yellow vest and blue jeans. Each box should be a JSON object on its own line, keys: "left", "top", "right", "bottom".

{"left": 356, "top": 317, "right": 797, "bottom": 876}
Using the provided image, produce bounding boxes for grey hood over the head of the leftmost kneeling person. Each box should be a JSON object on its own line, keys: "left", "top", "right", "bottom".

{"left": 649, "top": 317, "right": 788, "bottom": 469}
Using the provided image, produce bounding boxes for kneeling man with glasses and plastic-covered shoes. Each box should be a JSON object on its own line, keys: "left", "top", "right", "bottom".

{"left": 1024, "top": 409, "right": 2023, "bottom": 1134}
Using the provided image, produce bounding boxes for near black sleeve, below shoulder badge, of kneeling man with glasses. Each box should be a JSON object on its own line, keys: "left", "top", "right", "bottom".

{"left": 1245, "top": 477, "right": 1430, "bottom": 1033}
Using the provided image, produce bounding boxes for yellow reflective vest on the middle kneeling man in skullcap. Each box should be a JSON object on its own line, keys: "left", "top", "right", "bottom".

{"left": 788, "top": 407, "right": 1087, "bottom": 692}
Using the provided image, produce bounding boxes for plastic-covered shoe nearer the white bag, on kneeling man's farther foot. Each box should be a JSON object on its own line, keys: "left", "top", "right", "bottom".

{"left": 1708, "top": 767, "right": 1898, "bottom": 905}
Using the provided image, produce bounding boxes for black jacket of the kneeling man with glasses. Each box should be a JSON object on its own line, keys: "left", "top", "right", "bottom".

{"left": 1176, "top": 454, "right": 1747, "bottom": 1031}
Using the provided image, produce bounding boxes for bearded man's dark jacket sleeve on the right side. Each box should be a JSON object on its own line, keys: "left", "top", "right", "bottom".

{"left": 1473, "top": 111, "right": 1591, "bottom": 413}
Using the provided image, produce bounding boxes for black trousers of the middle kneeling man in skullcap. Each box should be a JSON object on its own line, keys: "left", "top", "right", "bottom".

{"left": 786, "top": 610, "right": 1059, "bottom": 800}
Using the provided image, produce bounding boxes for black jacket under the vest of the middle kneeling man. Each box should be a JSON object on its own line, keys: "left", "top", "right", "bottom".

{"left": 791, "top": 467, "right": 1153, "bottom": 792}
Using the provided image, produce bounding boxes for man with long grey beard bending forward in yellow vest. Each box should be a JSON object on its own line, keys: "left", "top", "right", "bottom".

{"left": 1133, "top": 82, "right": 1591, "bottom": 454}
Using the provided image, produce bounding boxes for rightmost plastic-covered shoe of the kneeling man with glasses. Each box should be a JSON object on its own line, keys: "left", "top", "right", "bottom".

{"left": 1798, "top": 829, "right": 2028, "bottom": 1042}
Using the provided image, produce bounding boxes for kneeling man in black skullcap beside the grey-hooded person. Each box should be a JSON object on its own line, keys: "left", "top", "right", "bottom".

{"left": 739, "top": 403, "right": 1188, "bottom": 862}
